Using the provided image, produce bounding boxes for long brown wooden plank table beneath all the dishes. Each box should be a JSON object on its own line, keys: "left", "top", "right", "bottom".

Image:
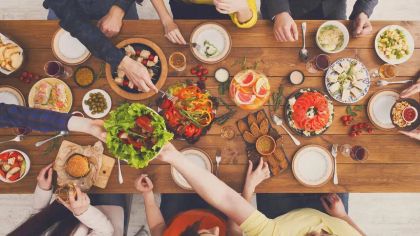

{"left": 0, "top": 20, "right": 420, "bottom": 193}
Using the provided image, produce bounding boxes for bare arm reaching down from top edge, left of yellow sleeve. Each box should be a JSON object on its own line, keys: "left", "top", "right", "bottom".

{"left": 151, "top": 0, "right": 187, "bottom": 44}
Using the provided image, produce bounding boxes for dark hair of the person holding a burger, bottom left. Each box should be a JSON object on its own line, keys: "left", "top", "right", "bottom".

{"left": 8, "top": 200, "right": 79, "bottom": 236}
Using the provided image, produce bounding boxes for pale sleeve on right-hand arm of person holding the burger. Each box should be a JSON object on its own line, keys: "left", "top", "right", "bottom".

{"left": 75, "top": 206, "right": 114, "bottom": 236}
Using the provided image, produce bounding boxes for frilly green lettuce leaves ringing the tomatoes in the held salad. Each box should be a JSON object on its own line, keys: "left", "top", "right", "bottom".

{"left": 104, "top": 103, "right": 174, "bottom": 169}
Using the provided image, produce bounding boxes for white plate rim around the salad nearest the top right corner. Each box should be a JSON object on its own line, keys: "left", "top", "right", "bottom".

{"left": 375, "top": 25, "right": 414, "bottom": 65}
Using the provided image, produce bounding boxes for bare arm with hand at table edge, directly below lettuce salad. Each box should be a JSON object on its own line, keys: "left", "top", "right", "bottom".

{"left": 135, "top": 174, "right": 166, "bottom": 236}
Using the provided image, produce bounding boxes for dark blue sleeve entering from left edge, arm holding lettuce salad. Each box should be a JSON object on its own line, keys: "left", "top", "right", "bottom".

{"left": 0, "top": 103, "right": 72, "bottom": 132}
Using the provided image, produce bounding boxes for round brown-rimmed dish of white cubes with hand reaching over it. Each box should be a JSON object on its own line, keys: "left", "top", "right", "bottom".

{"left": 105, "top": 38, "right": 168, "bottom": 100}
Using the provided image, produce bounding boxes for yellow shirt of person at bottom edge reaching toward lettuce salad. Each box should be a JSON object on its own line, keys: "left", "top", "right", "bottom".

{"left": 241, "top": 208, "right": 360, "bottom": 236}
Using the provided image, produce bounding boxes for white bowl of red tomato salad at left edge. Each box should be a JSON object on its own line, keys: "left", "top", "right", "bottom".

{"left": 0, "top": 149, "right": 31, "bottom": 183}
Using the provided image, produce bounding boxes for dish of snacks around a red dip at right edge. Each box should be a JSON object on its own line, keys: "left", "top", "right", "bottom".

{"left": 390, "top": 98, "right": 420, "bottom": 131}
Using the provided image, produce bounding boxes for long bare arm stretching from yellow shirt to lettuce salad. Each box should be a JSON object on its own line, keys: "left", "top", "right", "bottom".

{"left": 158, "top": 143, "right": 256, "bottom": 225}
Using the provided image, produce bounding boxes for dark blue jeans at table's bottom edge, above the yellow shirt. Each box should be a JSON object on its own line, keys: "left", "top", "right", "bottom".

{"left": 257, "top": 193, "right": 349, "bottom": 219}
